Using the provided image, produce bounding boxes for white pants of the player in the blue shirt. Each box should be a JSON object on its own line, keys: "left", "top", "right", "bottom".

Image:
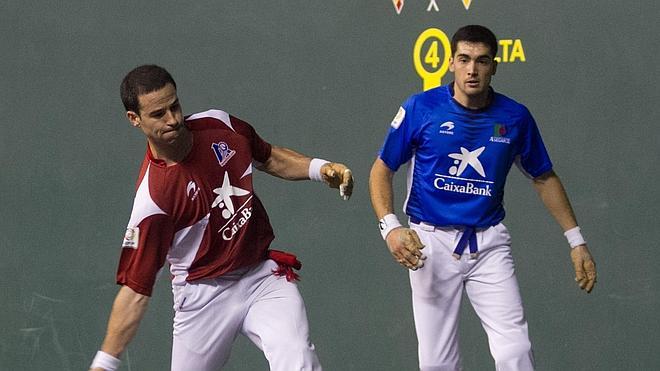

{"left": 410, "top": 223, "right": 534, "bottom": 371}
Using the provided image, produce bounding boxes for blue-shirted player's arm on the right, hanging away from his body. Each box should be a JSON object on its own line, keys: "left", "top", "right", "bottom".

{"left": 533, "top": 171, "right": 596, "bottom": 292}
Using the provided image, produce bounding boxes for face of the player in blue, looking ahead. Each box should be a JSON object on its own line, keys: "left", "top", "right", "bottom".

{"left": 449, "top": 41, "right": 497, "bottom": 106}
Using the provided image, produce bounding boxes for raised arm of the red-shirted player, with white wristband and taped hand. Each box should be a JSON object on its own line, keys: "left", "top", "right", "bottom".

{"left": 257, "top": 146, "right": 353, "bottom": 200}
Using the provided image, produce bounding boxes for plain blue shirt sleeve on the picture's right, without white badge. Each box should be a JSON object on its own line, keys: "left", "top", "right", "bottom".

{"left": 518, "top": 109, "right": 552, "bottom": 178}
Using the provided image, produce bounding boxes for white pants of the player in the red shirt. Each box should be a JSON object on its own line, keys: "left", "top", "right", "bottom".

{"left": 172, "top": 260, "right": 321, "bottom": 371}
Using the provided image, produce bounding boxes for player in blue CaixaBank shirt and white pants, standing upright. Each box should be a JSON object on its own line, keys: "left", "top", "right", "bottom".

{"left": 369, "top": 25, "right": 596, "bottom": 371}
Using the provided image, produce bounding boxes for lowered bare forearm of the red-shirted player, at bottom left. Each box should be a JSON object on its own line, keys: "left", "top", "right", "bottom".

{"left": 91, "top": 286, "right": 149, "bottom": 371}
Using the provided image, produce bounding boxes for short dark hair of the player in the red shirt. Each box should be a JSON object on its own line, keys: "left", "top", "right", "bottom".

{"left": 119, "top": 64, "right": 176, "bottom": 114}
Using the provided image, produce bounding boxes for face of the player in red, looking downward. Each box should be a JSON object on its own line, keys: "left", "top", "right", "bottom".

{"left": 126, "top": 84, "right": 186, "bottom": 144}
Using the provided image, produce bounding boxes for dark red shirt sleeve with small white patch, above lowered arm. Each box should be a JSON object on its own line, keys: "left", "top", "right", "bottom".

{"left": 117, "top": 214, "right": 174, "bottom": 296}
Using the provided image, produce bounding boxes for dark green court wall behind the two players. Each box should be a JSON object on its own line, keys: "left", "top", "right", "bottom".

{"left": 0, "top": 0, "right": 660, "bottom": 371}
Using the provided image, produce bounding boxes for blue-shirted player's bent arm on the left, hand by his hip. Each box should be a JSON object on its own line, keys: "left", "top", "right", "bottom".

{"left": 369, "top": 158, "right": 426, "bottom": 270}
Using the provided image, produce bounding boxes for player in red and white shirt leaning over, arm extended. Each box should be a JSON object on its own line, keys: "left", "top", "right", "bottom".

{"left": 91, "top": 65, "right": 353, "bottom": 371}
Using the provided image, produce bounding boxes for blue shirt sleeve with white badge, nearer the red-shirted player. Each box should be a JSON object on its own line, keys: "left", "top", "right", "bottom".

{"left": 379, "top": 97, "right": 418, "bottom": 171}
